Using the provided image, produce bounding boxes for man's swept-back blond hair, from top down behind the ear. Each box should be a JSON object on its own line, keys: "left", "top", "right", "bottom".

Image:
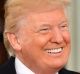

{"left": 4, "top": 0, "right": 68, "bottom": 55}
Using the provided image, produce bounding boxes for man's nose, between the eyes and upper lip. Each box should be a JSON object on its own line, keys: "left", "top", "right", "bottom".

{"left": 50, "top": 28, "right": 63, "bottom": 44}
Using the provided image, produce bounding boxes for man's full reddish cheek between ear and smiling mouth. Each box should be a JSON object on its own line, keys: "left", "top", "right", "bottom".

{"left": 22, "top": 36, "right": 48, "bottom": 58}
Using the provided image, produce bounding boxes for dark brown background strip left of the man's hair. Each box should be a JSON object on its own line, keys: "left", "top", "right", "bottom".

{"left": 0, "top": 0, "right": 8, "bottom": 64}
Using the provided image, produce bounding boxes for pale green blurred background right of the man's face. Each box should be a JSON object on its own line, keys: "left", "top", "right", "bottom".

{"left": 67, "top": 0, "right": 80, "bottom": 72}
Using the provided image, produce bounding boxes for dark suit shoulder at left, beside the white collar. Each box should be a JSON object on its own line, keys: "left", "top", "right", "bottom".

{"left": 0, "top": 57, "right": 16, "bottom": 74}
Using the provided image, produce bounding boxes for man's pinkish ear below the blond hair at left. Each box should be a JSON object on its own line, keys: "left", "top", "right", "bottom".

{"left": 7, "top": 33, "right": 21, "bottom": 51}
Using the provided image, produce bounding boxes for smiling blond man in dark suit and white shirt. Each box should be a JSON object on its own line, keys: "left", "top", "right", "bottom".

{"left": 0, "top": 0, "right": 78, "bottom": 74}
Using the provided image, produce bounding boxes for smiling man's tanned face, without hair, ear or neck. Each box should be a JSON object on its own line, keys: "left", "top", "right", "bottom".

{"left": 18, "top": 8, "right": 70, "bottom": 69}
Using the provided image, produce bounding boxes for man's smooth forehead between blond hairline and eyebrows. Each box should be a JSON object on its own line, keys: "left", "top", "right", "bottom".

{"left": 19, "top": 8, "right": 66, "bottom": 24}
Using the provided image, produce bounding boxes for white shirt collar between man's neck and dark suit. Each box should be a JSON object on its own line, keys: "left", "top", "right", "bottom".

{"left": 15, "top": 57, "right": 58, "bottom": 74}
